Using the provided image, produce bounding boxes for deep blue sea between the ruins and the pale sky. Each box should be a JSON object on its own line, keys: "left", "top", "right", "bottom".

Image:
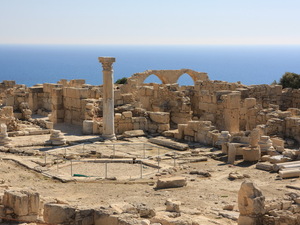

{"left": 0, "top": 45, "right": 300, "bottom": 86}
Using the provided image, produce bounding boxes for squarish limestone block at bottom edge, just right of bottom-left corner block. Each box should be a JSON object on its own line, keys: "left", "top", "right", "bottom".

{"left": 43, "top": 203, "right": 76, "bottom": 224}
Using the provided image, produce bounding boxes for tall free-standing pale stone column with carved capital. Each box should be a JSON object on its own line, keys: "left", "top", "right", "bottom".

{"left": 98, "top": 57, "right": 116, "bottom": 140}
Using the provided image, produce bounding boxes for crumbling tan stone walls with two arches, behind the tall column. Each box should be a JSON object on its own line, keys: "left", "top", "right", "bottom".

{"left": 0, "top": 65, "right": 300, "bottom": 159}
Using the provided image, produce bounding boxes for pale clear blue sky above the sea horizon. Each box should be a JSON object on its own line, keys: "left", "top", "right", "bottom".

{"left": 0, "top": 0, "right": 300, "bottom": 45}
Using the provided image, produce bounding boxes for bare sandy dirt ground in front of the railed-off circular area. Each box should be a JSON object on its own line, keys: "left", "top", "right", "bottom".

{"left": 0, "top": 124, "right": 300, "bottom": 224}
